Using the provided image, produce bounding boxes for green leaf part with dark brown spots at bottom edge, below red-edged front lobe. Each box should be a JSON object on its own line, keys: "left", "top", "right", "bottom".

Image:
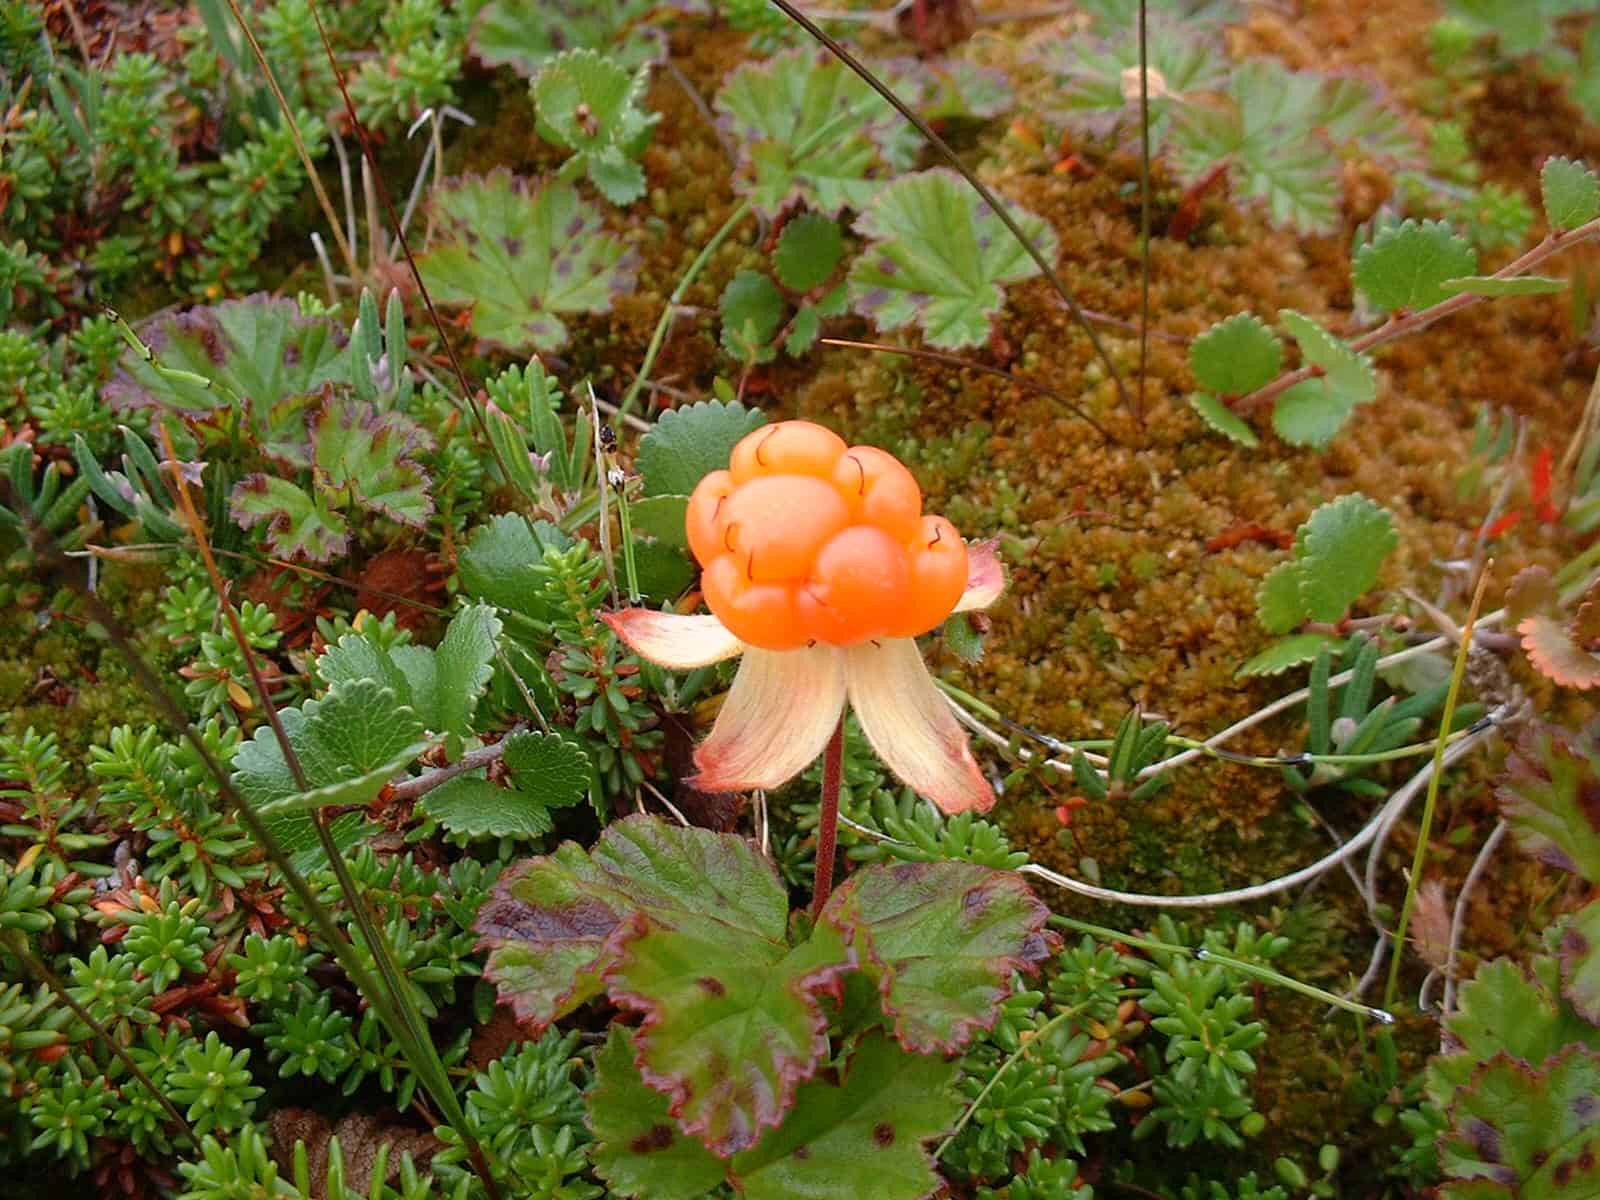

{"left": 587, "top": 1026, "right": 723, "bottom": 1200}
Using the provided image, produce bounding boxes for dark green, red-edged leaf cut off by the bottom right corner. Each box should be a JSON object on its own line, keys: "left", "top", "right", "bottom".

{"left": 1438, "top": 1046, "right": 1600, "bottom": 1200}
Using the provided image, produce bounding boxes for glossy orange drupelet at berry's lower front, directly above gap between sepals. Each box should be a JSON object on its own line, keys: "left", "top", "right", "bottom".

{"left": 795, "top": 525, "right": 910, "bottom": 646}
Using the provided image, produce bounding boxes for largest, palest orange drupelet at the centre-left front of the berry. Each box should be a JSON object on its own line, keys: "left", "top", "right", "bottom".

{"left": 722, "top": 475, "right": 850, "bottom": 582}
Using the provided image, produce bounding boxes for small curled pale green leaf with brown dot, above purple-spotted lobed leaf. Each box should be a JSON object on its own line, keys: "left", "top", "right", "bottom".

{"left": 531, "top": 50, "right": 659, "bottom": 205}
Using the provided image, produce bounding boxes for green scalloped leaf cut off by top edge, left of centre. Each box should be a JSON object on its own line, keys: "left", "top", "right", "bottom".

{"left": 469, "top": 0, "right": 666, "bottom": 75}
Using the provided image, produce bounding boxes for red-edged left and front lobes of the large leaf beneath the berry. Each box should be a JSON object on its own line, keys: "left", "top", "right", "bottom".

{"left": 477, "top": 818, "right": 848, "bottom": 1155}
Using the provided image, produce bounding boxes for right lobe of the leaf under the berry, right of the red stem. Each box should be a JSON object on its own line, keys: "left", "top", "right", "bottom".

{"left": 819, "top": 861, "right": 1054, "bottom": 1054}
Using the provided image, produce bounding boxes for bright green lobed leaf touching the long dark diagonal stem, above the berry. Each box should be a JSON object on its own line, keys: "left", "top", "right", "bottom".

{"left": 850, "top": 168, "right": 1056, "bottom": 349}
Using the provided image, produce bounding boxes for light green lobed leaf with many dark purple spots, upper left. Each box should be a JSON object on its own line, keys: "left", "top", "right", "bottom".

{"left": 418, "top": 170, "right": 637, "bottom": 352}
